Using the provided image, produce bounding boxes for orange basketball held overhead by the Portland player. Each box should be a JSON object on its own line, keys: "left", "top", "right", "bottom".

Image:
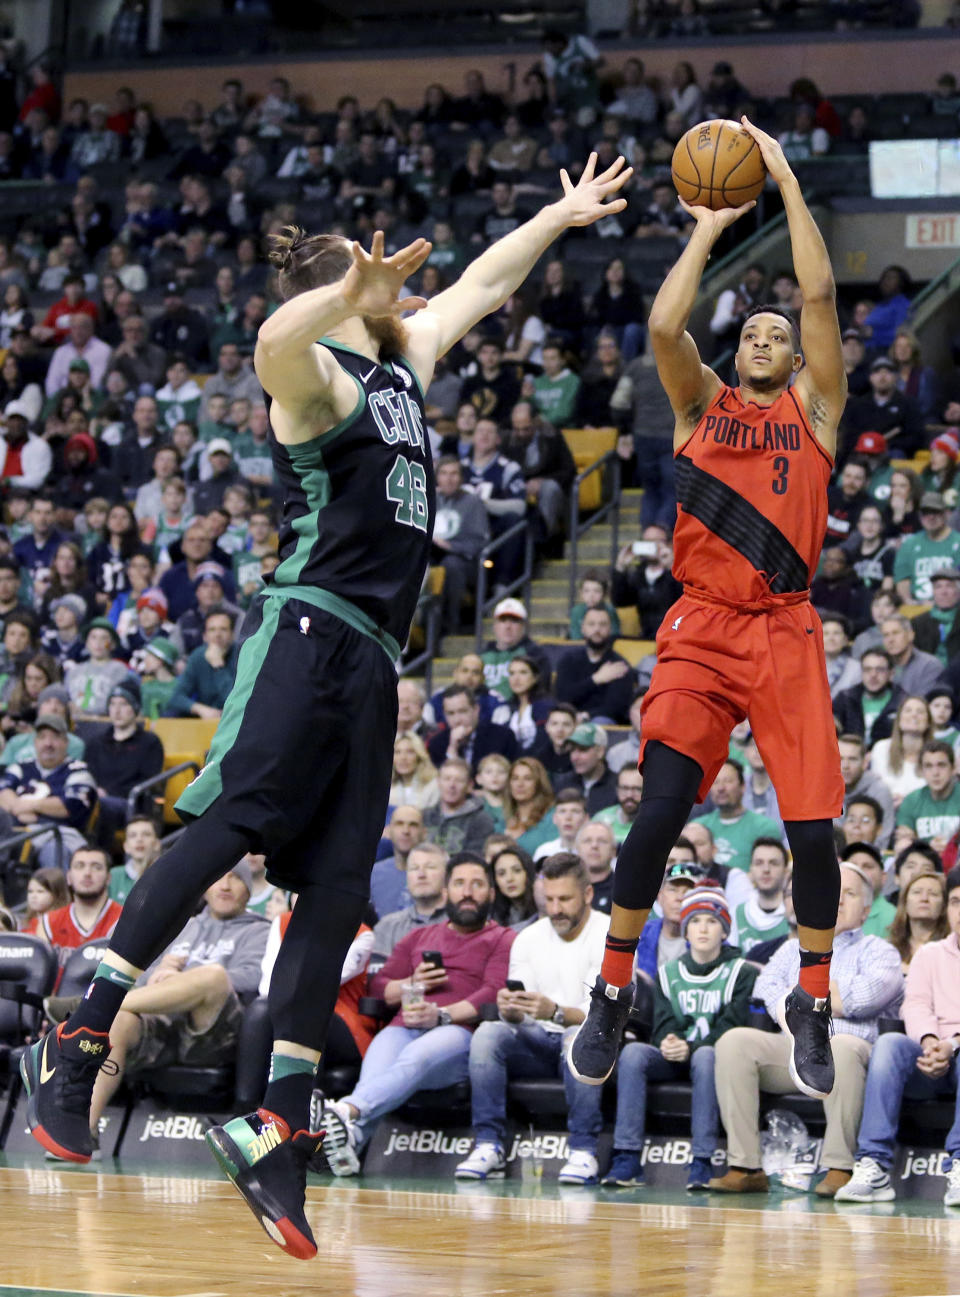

{"left": 671, "top": 117, "right": 767, "bottom": 211}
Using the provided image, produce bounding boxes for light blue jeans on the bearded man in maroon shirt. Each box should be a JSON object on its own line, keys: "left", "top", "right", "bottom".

{"left": 344, "top": 1023, "right": 471, "bottom": 1148}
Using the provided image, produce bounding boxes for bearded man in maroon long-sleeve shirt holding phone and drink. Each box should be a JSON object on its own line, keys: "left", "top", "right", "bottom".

{"left": 322, "top": 851, "right": 516, "bottom": 1175}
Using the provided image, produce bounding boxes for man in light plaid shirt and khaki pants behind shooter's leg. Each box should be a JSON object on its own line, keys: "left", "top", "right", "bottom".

{"left": 710, "top": 861, "right": 903, "bottom": 1198}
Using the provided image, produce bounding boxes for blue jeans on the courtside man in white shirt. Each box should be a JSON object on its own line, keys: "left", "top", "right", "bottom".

{"left": 470, "top": 1022, "right": 603, "bottom": 1153}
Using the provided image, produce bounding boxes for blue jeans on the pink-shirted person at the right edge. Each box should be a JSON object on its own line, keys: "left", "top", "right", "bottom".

{"left": 856, "top": 1031, "right": 960, "bottom": 1169}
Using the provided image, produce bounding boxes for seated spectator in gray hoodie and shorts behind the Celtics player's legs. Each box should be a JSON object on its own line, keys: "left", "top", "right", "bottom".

{"left": 76, "top": 860, "right": 270, "bottom": 1141}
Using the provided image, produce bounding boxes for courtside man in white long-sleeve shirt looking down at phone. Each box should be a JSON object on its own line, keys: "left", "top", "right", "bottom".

{"left": 454, "top": 852, "right": 607, "bottom": 1184}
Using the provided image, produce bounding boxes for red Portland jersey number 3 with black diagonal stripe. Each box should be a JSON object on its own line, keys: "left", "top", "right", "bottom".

{"left": 673, "top": 387, "right": 833, "bottom": 603}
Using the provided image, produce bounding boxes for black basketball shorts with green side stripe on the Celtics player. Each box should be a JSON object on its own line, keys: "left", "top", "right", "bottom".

{"left": 176, "top": 594, "right": 397, "bottom": 898}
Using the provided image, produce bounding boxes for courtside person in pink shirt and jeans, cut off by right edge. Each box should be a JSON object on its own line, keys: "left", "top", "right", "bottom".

{"left": 834, "top": 868, "right": 960, "bottom": 1208}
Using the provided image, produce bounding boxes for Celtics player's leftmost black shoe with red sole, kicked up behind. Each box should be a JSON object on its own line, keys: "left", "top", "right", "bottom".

{"left": 19, "top": 1023, "right": 115, "bottom": 1162}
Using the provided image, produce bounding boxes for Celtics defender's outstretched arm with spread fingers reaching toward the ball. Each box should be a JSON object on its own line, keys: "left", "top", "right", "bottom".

{"left": 409, "top": 153, "right": 633, "bottom": 376}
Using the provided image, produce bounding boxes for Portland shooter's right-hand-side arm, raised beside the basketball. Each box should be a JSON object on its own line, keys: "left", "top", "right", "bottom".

{"left": 741, "top": 117, "right": 847, "bottom": 454}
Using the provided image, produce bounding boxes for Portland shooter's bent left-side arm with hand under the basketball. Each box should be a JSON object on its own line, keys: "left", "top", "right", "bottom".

{"left": 647, "top": 191, "right": 756, "bottom": 441}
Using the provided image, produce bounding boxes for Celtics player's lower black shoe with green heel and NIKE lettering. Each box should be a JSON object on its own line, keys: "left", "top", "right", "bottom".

{"left": 205, "top": 1108, "right": 323, "bottom": 1261}
